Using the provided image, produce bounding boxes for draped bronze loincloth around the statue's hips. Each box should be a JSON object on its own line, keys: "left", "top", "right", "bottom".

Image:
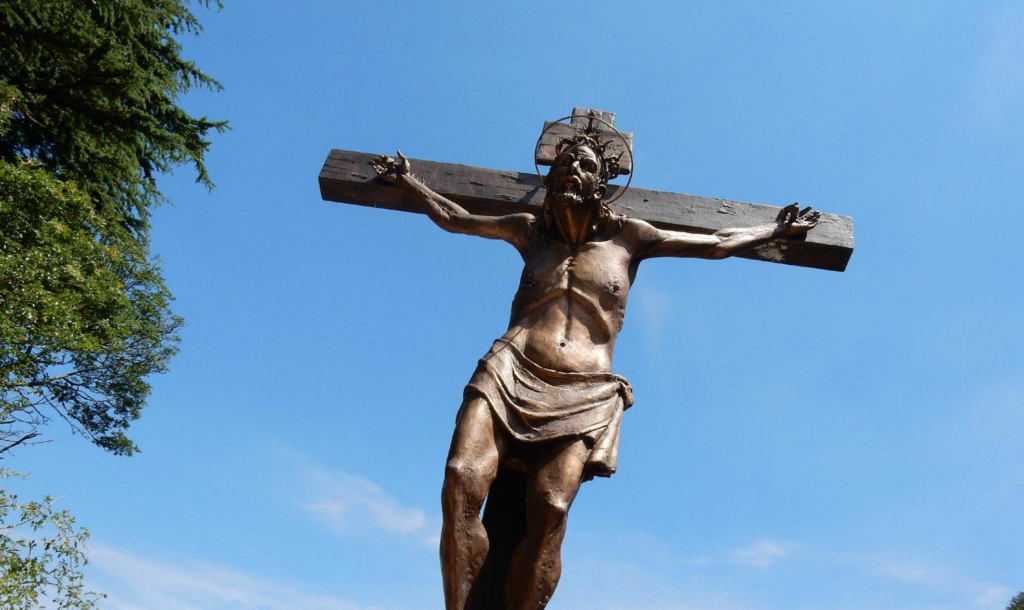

{"left": 466, "top": 340, "right": 633, "bottom": 479}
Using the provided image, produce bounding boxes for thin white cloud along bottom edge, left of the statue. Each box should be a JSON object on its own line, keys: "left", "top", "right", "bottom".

{"left": 89, "top": 542, "right": 374, "bottom": 610}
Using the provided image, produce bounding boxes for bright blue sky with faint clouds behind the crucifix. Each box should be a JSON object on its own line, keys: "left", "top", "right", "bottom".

{"left": 10, "top": 0, "right": 1024, "bottom": 610}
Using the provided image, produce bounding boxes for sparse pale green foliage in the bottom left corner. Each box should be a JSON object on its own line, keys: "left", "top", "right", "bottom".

{"left": 0, "top": 469, "right": 101, "bottom": 610}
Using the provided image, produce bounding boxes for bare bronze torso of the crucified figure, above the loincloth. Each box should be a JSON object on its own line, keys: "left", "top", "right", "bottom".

{"left": 503, "top": 219, "right": 636, "bottom": 373}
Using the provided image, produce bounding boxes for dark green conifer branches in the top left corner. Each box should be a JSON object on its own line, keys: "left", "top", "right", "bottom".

{"left": 0, "top": 0, "right": 225, "bottom": 233}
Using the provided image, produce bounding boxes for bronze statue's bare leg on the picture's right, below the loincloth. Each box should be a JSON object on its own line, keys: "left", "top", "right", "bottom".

{"left": 505, "top": 439, "right": 590, "bottom": 610}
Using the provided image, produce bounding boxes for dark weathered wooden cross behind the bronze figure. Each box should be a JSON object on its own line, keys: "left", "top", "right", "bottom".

{"left": 319, "top": 108, "right": 853, "bottom": 271}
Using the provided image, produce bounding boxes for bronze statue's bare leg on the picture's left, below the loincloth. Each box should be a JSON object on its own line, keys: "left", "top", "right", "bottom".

{"left": 441, "top": 397, "right": 505, "bottom": 610}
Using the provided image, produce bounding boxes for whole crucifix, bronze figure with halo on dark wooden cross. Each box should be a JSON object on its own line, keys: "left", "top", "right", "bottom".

{"left": 321, "top": 108, "right": 853, "bottom": 610}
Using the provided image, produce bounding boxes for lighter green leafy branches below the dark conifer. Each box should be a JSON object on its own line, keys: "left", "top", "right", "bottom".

{"left": 0, "top": 162, "right": 181, "bottom": 454}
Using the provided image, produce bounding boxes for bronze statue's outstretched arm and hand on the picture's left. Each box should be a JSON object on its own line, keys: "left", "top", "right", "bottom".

{"left": 371, "top": 150, "right": 536, "bottom": 252}
